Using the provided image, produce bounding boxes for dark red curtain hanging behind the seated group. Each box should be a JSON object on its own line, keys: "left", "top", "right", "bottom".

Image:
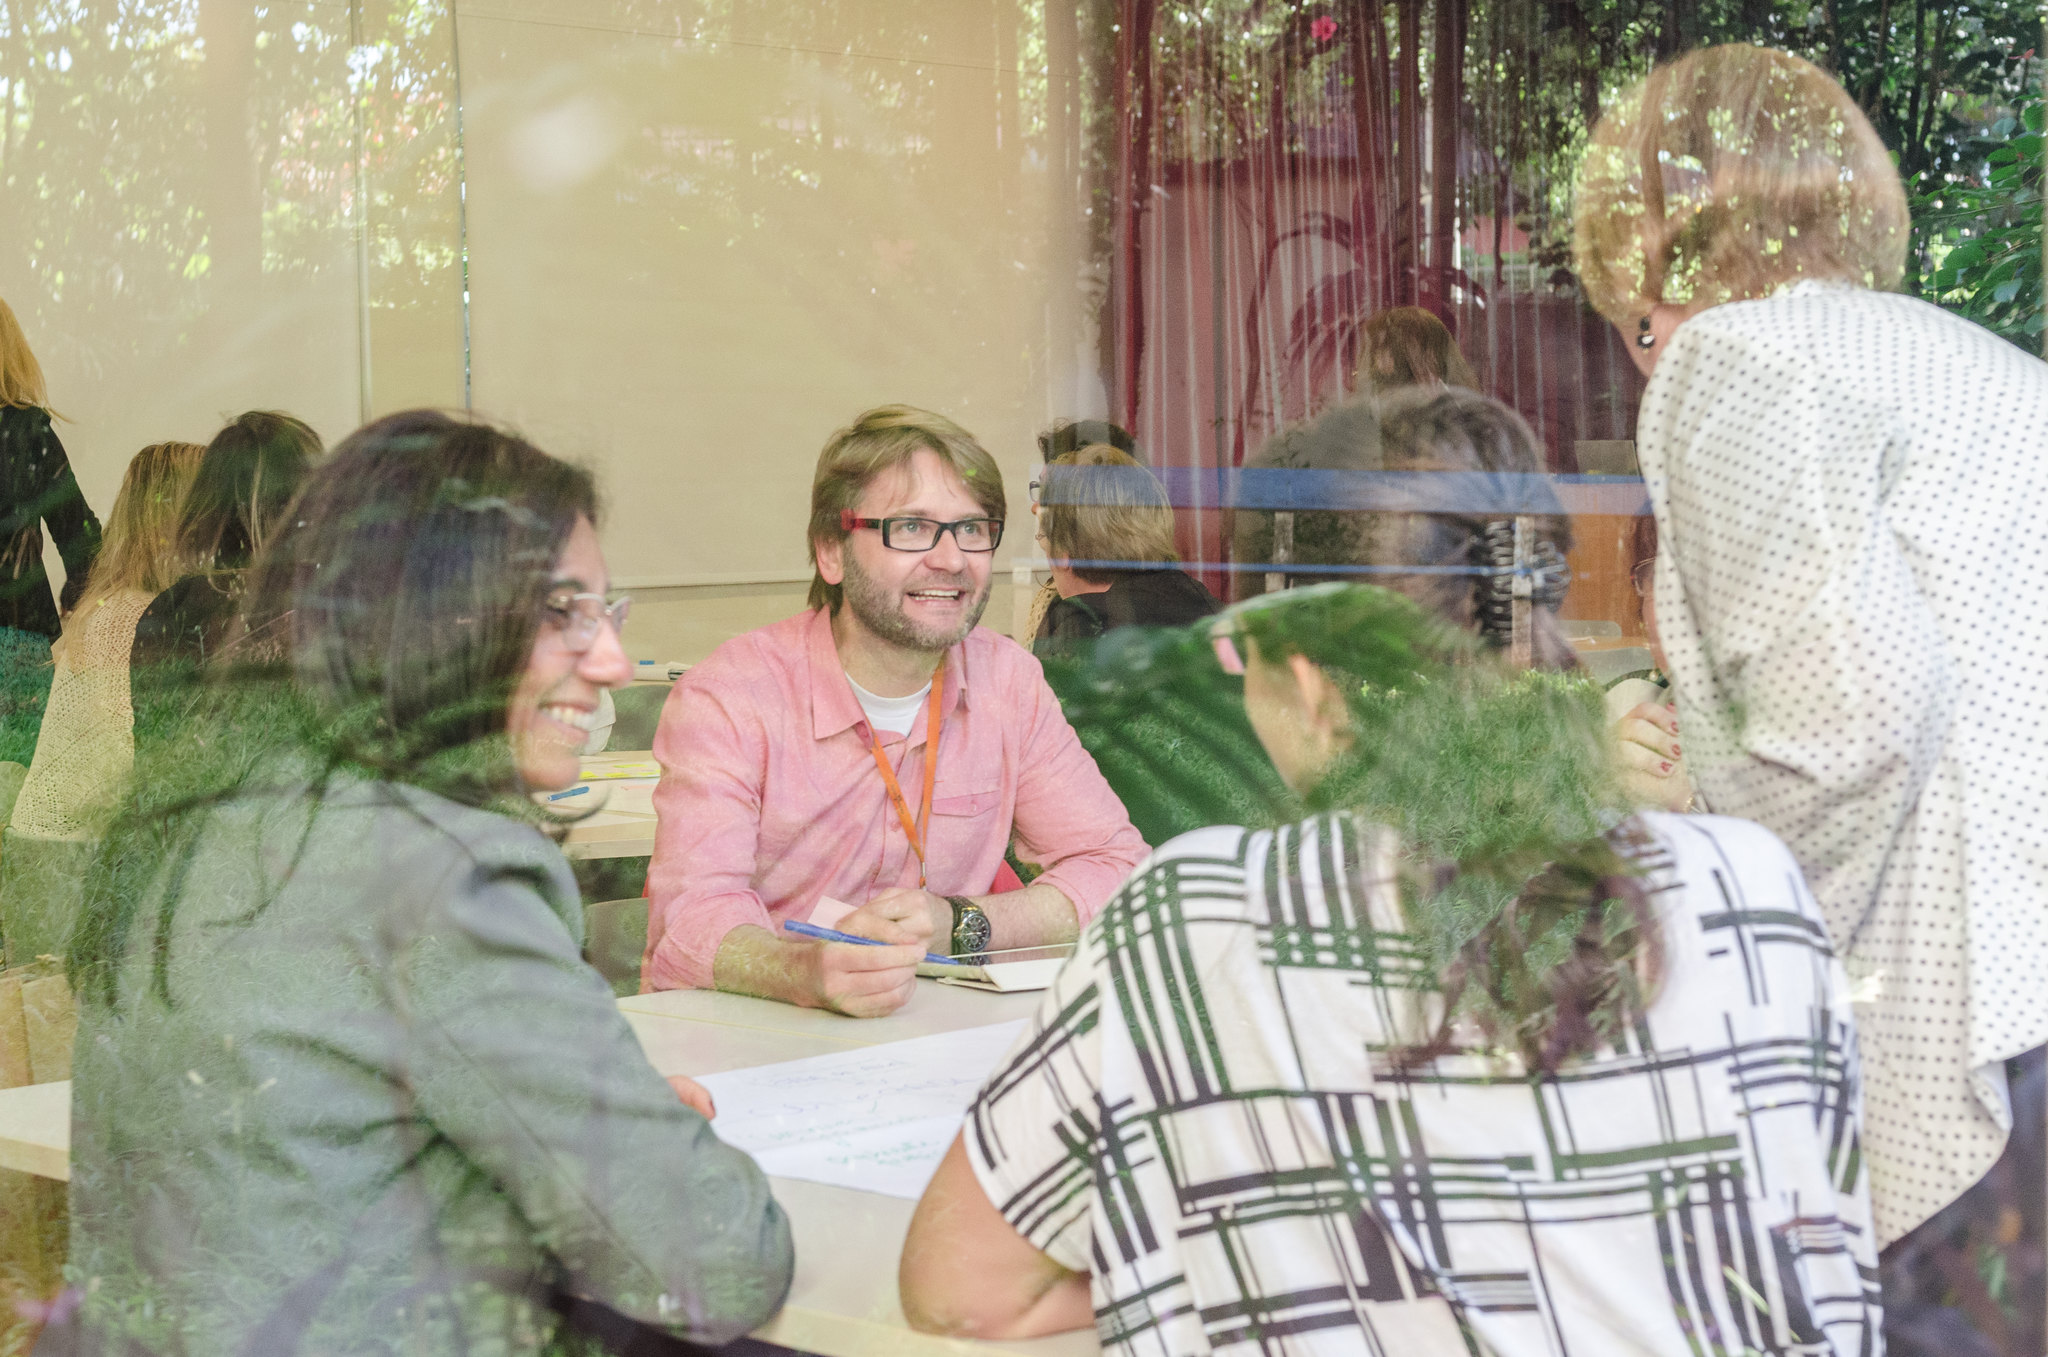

{"left": 1106, "top": 0, "right": 1636, "bottom": 592}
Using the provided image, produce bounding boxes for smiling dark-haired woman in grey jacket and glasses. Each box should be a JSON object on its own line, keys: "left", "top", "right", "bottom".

{"left": 56, "top": 411, "right": 791, "bottom": 1353}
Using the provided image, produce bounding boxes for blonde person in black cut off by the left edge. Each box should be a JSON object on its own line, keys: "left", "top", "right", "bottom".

{"left": 0, "top": 301, "right": 100, "bottom": 641}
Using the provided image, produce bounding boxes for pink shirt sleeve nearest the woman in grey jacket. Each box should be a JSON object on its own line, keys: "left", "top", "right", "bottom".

{"left": 641, "top": 675, "right": 772, "bottom": 991}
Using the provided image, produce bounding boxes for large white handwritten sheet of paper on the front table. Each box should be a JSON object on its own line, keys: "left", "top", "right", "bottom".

{"left": 696, "top": 1019, "right": 1024, "bottom": 1199}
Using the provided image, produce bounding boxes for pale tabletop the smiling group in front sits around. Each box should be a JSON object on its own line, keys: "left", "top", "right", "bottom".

{"left": 0, "top": 980, "right": 1100, "bottom": 1357}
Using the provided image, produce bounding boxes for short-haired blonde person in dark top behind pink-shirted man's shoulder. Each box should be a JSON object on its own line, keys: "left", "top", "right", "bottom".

{"left": 1032, "top": 444, "right": 1221, "bottom": 655}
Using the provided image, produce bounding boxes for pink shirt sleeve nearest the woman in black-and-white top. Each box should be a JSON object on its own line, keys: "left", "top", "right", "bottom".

{"left": 1012, "top": 661, "right": 1147, "bottom": 923}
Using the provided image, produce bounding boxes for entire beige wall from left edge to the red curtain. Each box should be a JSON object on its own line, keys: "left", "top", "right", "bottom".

{"left": 0, "top": 0, "right": 1073, "bottom": 638}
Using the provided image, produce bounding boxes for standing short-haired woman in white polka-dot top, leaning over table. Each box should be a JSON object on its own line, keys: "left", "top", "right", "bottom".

{"left": 1575, "top": 45, "right": 2048, "bottom": 1357}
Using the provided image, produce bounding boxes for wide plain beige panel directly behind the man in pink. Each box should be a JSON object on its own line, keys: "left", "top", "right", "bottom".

{"left": 461, "top": 0, "right": 1071, "bottom": 593}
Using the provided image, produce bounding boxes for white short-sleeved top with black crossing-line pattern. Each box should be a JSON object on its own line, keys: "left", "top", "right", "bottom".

{"left": 967, "top": 815, "right": 1880, "bottom": 1357}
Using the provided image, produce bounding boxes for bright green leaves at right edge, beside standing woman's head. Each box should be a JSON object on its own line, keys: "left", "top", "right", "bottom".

{"left": 1913, "top": 92, "right": 2048, "bottom": 350}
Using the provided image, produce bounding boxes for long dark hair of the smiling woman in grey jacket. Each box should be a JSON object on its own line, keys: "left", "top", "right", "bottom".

{"left": 72, "top": 409, "right": 598, "bottom": 1003}
